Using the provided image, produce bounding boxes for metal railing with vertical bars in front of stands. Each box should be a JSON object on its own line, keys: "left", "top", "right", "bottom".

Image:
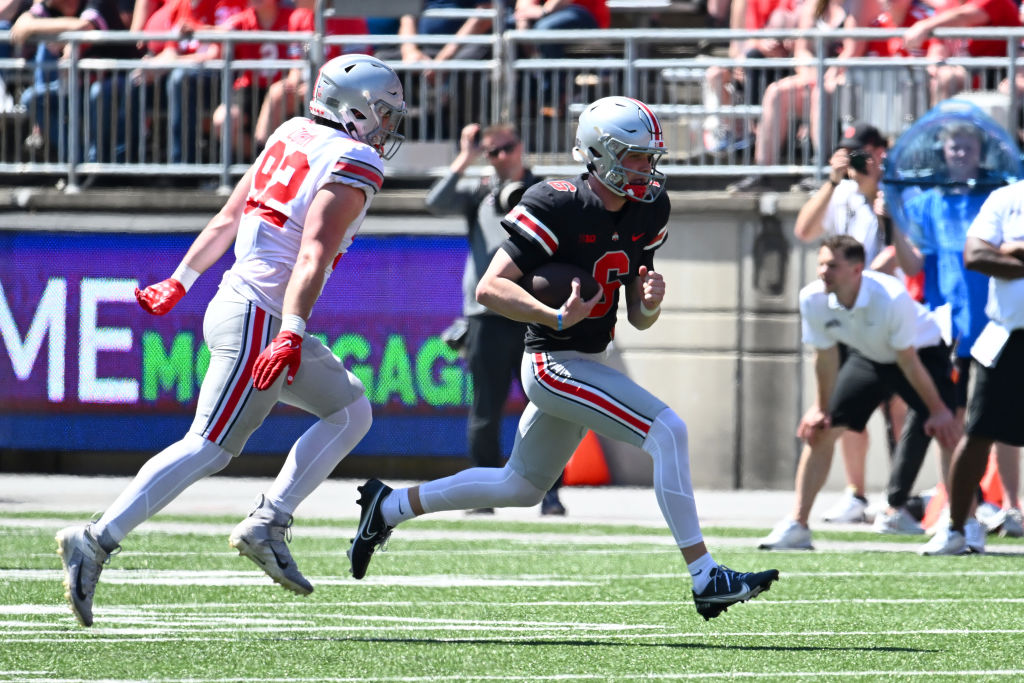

{"left": 0, "top": 29, "right": 1024, "bottom": 189}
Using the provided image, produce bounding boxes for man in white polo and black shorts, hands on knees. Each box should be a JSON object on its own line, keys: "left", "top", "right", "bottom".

{"left": 759, "top": 234, "right": 961, "bottom": 550}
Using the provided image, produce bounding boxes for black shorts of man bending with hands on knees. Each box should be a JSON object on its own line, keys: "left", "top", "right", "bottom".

{"left": 827, "top": 346, "right": 956, "bottom": 431}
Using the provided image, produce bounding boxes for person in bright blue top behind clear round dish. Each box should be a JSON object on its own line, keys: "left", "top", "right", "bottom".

{"left": 903, "top": 121, "right": 1024, "bottom": 551}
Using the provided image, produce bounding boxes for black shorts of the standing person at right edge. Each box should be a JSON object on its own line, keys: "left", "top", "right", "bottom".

{"left": 967, "top": 330, "right": 1024, "bottom": 445}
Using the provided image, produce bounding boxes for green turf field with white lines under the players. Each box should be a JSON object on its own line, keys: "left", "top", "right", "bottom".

{"left": 0, "top": 513, "right": 1024, "bottom": 683}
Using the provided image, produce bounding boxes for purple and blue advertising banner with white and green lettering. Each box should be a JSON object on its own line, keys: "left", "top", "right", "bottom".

{"left": 0, "top": 231, "right": 524, "bottom": 456}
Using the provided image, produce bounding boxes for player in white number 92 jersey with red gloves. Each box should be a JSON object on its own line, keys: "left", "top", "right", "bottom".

{"left": 56, "top": 55, "right": 406, "bottom": 626}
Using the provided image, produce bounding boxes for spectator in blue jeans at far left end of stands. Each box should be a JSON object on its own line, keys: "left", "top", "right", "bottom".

{"left": 10, "top": 0, "right": 141, "bottom": 162}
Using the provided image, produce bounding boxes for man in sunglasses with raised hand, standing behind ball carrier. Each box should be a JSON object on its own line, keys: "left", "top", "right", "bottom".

{"left": 426, "top": 123, "right": 565, "bottom": 515}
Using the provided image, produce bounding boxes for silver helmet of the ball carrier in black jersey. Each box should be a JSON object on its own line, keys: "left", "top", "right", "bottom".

{"left": 572, "top": 96, "right": 666, "bottom": 203}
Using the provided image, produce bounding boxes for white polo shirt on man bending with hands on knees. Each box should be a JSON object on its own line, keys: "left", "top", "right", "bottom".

{"left": 800, "top": 270, "right": 942, "bottom": 364}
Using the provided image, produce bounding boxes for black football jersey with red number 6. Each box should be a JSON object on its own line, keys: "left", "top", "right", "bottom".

{"left": 502, "top": 173, "right": 669, "bottom": 353}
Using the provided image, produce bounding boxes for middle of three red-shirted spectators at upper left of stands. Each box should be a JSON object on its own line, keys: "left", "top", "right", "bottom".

{"left": 212, "top": 0, "right": 296, "bottom": 161}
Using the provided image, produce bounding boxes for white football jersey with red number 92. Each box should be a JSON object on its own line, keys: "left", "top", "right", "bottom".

{"left": 221, "top": 118, "right": 384, "bottom": 317}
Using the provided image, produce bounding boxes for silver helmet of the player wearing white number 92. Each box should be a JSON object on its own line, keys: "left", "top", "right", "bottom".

{"left": 309, "top": 54, "right": 406, "bottom": 159}
